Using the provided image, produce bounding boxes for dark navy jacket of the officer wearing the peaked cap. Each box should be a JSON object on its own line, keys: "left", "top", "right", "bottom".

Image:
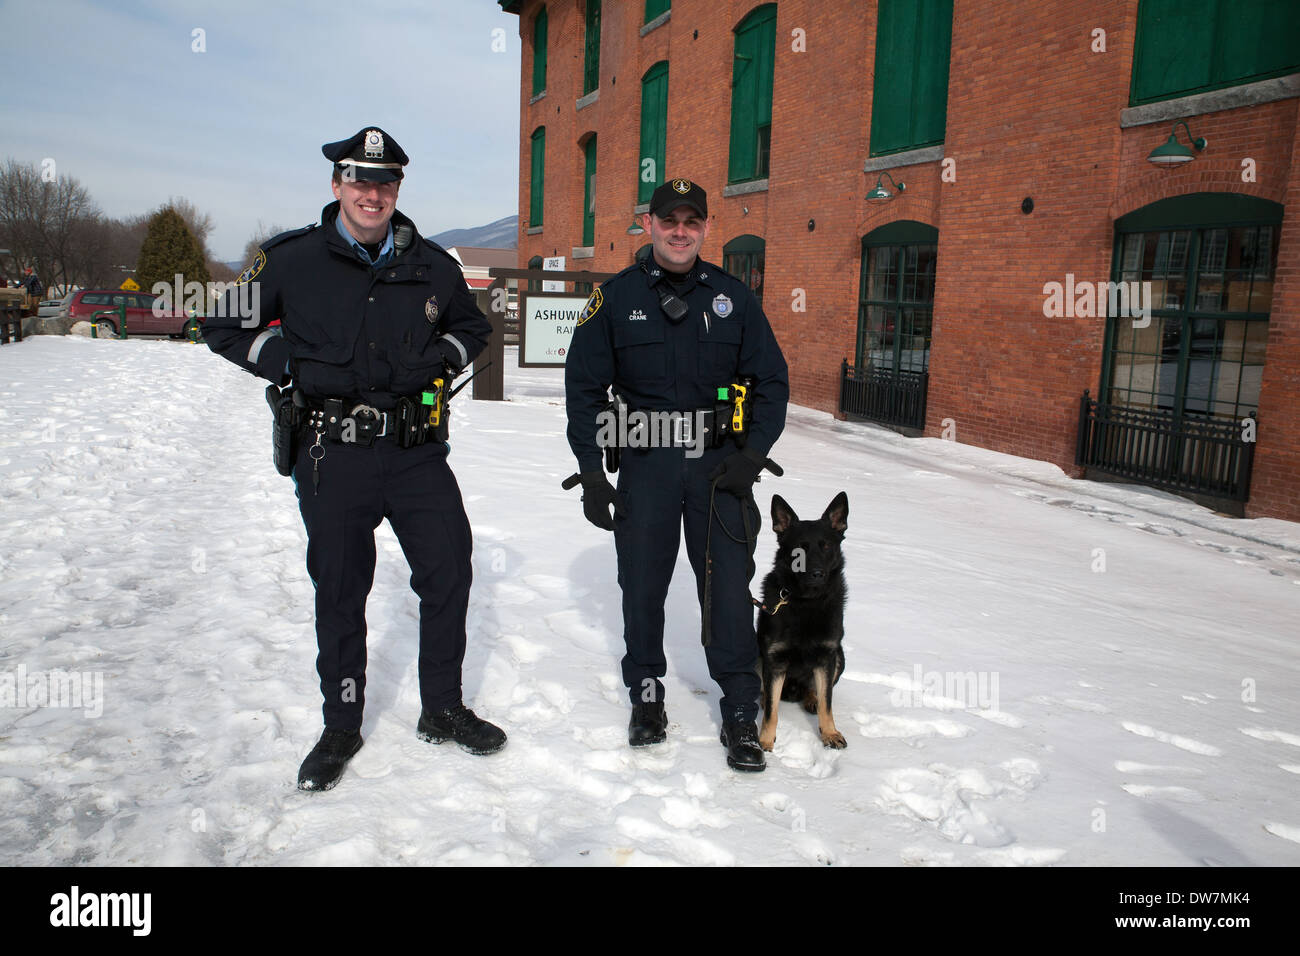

{"left": 203, "top": 202, "right": 491, "bottom": 408}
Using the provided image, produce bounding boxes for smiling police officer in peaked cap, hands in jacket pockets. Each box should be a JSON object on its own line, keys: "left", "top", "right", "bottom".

{"left": 203, "top": 126, "right": 506, "bottom": 790}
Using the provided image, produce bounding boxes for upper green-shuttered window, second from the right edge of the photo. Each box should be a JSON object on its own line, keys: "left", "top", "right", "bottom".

{"left": 871, "top": 0, "right": 953, "bottom": 156}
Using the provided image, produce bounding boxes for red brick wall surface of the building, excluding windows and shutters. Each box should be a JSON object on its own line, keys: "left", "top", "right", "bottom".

{"left": 504, "top": 0, "right": 1300, "bottom": 519}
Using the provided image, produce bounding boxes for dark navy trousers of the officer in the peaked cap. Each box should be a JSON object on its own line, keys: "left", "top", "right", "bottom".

{"left": 294, "top": 438, "right": 473, "bottom": 730}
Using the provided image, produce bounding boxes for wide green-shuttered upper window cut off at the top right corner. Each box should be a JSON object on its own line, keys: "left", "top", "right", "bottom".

{"left": 1128, "top": 0, "right": 1300, "bottom": 105}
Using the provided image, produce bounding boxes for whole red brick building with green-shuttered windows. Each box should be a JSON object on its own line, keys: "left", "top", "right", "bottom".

{"left": 498, "top": 0, "right": 1300, "bottom": 520}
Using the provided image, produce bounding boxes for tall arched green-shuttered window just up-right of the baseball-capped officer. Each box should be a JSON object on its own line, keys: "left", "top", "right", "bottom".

{"left": 727, "top": 4, "right": 776, "bottom": 182}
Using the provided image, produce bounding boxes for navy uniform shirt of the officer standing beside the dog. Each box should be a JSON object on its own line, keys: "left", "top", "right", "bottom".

{"left": 564, "top": 254, "right": 790, "bottom": 471}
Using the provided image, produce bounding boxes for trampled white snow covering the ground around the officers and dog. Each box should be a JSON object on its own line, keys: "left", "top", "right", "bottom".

{"left": 0, "top": 337, "right": 1300, "bottom": 865}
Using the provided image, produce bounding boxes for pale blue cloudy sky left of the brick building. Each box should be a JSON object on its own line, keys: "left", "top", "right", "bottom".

{"left": 0, "top": 0, "right": 520, "bottom": 260}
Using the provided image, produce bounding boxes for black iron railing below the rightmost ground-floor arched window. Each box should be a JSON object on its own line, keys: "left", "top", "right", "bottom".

{"left": 1075, "top": 392, "right": 1256, "bottom": 501}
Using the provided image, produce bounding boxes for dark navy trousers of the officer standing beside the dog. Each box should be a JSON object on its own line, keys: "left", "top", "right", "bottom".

{"left": 614, "top": 444, "right": 759, "bottom": 721}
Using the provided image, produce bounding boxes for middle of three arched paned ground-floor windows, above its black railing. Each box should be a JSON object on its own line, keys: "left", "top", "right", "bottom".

{"left": 854, "top": 220, "right": 939, "bottom": 372}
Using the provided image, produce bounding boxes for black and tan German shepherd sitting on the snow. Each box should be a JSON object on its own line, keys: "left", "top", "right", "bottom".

{"left": 758, "top": 492, "right": 849, "bottom": 750}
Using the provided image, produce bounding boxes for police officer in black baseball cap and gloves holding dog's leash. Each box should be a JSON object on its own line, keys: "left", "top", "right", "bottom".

{"left": 564, "top": 179, "right": 789, "bottom": 770}
